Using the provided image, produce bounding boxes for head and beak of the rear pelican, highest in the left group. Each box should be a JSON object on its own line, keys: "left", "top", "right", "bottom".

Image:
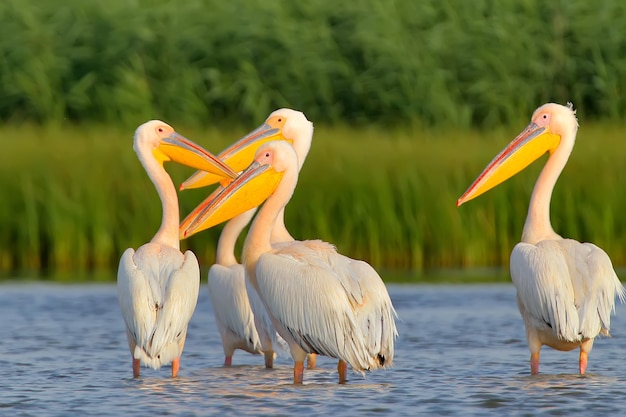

{"left": 180, "top": 108, "right": 313, "bottom": 190}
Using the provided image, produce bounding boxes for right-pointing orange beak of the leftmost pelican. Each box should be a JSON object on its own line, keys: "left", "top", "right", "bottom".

{"left": 158, "top": 132, "right": 237, "bottom": 179}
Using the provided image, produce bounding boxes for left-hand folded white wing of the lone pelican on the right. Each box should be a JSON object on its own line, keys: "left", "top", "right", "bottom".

{"left": 511, "top": 240, "right": 581, "bottom": 341}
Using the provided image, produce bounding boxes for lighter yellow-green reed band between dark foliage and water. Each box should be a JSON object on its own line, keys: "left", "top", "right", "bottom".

{"left": 0, "top": 121, "right": 626, "bottom": 279}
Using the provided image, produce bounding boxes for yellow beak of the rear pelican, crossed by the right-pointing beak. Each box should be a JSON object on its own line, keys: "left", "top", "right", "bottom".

{"left": 180, "top": 116, "right": 293, "bottom": 190}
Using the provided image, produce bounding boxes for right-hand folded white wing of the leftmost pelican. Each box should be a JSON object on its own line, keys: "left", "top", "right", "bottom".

{"left": 148, "top": 251, "right": 200, "bottom": 363}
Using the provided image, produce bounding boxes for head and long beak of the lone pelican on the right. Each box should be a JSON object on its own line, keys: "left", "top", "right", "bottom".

{"left": 456, "top": 103, "right": 578, "bottom": 206}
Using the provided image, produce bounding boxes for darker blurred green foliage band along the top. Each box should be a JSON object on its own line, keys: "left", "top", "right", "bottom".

{"left": 0, "top": 0, "right": 626, "bottom": 128}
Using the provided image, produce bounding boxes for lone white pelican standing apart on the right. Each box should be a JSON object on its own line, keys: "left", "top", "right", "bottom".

{"left": 457, "top": 103, "right": 624, "bottom": 375}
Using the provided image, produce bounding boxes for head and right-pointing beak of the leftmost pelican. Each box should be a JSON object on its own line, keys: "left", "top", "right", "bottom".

{"left": 133, "top": 120, "right": 237, "bottom": 178}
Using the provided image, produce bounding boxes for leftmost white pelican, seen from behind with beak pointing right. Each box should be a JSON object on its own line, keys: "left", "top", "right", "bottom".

{"left": 117, "top": 120, "right": 237, "bottom": 378}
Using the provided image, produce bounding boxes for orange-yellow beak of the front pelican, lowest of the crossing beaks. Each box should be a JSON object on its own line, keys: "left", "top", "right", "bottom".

{"left": 179, "top": 161, "right": 284, "bottom": 239}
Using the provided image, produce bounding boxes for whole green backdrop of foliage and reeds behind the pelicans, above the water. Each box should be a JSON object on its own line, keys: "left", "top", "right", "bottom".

{"left": 0, "top": 0, "right": 626, "bottom": 281}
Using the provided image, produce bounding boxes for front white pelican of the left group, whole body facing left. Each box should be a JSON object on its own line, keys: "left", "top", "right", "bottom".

{"left": 180, "top": 141, "right": 397, "bottom": 384}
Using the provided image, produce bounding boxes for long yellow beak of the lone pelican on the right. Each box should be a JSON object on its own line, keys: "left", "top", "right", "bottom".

{"left": 456, "top": 123, "right": 561, "bottom": 207}
